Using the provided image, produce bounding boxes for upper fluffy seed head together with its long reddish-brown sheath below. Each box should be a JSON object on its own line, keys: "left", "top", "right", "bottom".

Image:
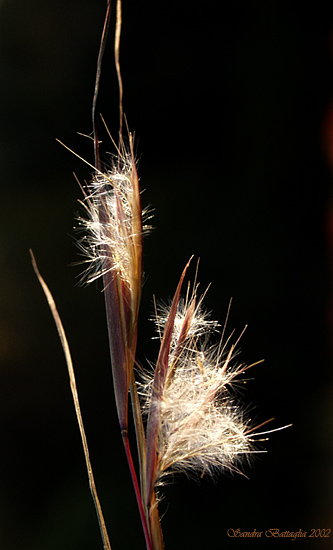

{"left": 78, "top": 135, "right": 148, "bottom": 430}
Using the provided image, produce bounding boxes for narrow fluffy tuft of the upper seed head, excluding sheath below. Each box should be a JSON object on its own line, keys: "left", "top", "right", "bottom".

{"left": 78, "top": 150, "right": 145, "bottom": 296}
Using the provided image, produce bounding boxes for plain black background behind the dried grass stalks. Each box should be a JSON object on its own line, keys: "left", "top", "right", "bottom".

{"left": 0, "top": 0, "right": 333, "bottom": 550}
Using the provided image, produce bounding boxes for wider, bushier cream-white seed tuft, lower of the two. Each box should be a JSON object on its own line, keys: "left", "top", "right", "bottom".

{"left": 139, "top": 284, "right": 262, "bottom": 500}
